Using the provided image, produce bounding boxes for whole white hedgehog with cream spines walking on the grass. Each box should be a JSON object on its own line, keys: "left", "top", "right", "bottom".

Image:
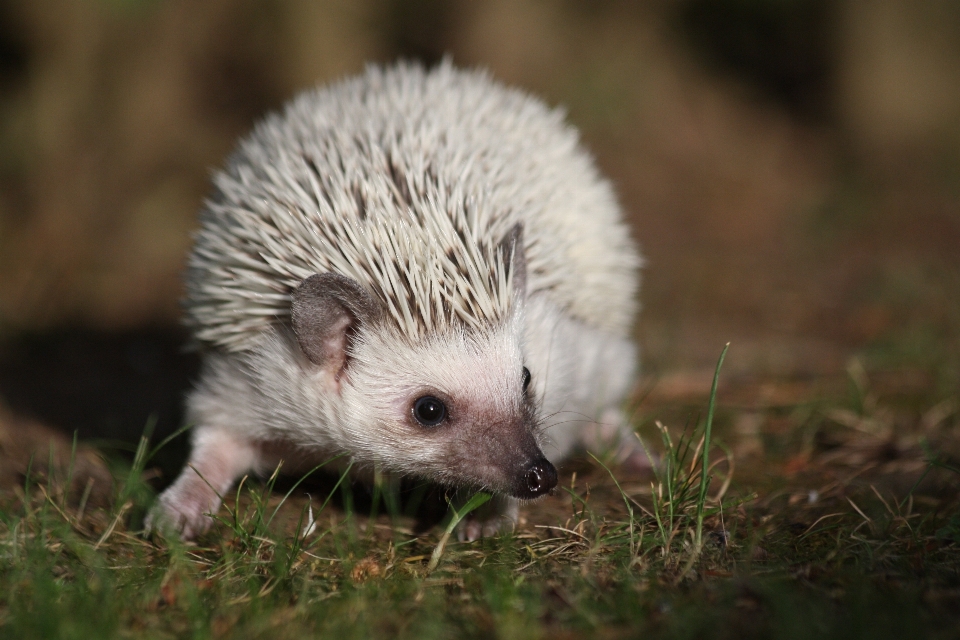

{"left": 148, "top": 62, "right": 640, "bottom": 539}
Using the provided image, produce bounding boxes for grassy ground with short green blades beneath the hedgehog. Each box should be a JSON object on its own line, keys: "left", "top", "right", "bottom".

{"left": 0, "top": 348, "right": 960, "bottom": 640}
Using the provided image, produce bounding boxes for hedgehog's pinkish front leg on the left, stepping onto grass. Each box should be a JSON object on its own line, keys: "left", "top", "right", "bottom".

{"left": 145, "top": 427, "right": 258, "bottom": 540}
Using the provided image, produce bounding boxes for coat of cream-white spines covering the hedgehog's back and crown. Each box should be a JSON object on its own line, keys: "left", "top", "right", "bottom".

{"left": 185, "top": 63, "right": 638, "bottom": 351}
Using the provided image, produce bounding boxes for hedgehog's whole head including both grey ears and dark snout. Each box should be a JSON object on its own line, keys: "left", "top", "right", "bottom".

{"left": 291, "top": 232, "right": 557, "bottom": 498}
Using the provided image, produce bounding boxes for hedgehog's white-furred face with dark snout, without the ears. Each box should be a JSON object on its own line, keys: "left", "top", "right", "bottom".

{"left": 340, "top": 314, "right": 557, "bottom": 498}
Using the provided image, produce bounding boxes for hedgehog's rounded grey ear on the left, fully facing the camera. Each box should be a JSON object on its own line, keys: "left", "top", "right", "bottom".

{"left": 290, "top": 273, "right": 380, "bottom": 382}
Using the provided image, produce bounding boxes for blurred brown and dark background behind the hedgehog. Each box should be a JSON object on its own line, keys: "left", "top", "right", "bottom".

{"left": 0, "top": 0, "right": 960, "bottom": 465}
